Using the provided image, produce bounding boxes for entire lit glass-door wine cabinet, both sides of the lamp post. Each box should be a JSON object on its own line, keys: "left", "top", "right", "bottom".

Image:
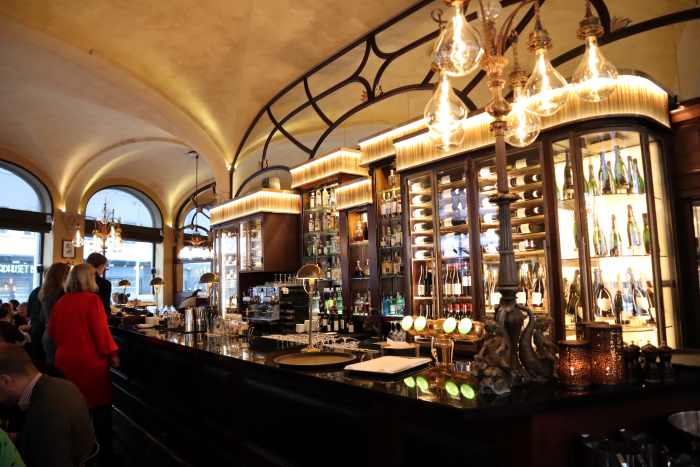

{"left": 401, "top": 117, "right": 677, "bottom": 346}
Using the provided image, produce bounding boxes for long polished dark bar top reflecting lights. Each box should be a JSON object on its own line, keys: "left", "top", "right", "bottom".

{"left": 113, "top": 327, "right": 700, "bottom": 417}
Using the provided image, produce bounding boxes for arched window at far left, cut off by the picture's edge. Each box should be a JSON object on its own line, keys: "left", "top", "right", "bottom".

{"left": 0, "top": 161, "right": 52, "bottom": 302}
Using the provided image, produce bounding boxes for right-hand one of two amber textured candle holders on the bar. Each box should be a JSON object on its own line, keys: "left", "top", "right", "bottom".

{"left": 588, "top": 323, "right": 625, "bottom": 386}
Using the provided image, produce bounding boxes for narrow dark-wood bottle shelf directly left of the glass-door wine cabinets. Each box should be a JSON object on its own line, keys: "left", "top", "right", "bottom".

{"left": 373, "top": 162, "right": 406, "bottom": 319}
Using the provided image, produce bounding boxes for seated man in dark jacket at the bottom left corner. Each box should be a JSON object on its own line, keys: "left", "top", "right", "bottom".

{"left": 0, "top": 344, "right": 97, "bottom": 467}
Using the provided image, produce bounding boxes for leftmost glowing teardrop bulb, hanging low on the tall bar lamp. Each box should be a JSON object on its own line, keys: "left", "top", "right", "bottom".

{"left": 423, "top": 73, "right": 467, "bottom": 151}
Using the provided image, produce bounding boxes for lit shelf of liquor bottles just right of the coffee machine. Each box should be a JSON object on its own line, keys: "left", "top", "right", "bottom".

{"left": 302, "top": 184, "right": 342, "bottom": 287}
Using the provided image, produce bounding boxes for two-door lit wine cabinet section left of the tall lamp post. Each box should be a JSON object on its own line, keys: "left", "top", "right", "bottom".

{"left": 405, "top": 163, "right": 473, "bottom": 319}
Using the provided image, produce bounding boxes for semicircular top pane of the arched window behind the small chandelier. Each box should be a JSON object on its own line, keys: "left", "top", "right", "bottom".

{"left": 85, "top": 187, "right": 162, "bottom": 228}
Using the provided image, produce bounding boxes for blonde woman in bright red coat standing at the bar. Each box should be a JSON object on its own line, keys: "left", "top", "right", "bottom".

{"left": 49, "top": 264, "right": 119, "bottom": 460}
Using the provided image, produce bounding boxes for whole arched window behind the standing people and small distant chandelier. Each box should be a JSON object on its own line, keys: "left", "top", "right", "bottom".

{"left": 84, "top": 187, "right": 162, "bottom": 301}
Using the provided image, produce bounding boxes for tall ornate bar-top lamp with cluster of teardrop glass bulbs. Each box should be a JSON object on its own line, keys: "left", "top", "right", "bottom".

{"left": 424, "top": 0, "right": 617, "bottom": 394}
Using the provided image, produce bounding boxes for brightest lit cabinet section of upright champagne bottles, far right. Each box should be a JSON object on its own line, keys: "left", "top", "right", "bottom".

{"left": 553, "top": 131, "right": 663, "bottom": 345}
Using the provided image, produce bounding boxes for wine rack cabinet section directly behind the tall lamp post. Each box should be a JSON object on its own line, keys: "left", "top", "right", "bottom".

{"left": 476, "top": 149, "right": 551, "bottom": 322}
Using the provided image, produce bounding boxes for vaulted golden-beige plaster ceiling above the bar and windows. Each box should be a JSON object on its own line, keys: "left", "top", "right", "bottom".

{"left": 0, "top": 0, "right": 700, "bottom": 219}
